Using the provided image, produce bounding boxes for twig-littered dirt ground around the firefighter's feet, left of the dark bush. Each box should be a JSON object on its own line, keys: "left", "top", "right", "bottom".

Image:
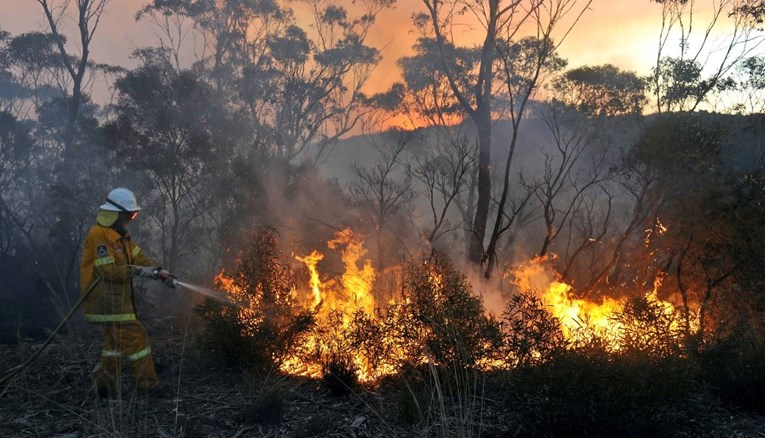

{"left": 0, "top": 321, "right": 765, "bottom": 438}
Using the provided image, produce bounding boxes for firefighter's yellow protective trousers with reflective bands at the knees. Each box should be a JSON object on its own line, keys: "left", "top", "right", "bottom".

{"left": 94, "top": 321, "right": 159, "bottom": 394}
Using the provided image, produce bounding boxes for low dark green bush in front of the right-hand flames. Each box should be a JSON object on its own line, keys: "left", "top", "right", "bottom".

{"left": 506, "top": 349, "right": 701, "bottom": 437}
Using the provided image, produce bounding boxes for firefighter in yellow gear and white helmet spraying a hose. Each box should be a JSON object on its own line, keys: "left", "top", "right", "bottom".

{"left": 80, "top": 188, "right": 175, "bottom": 397}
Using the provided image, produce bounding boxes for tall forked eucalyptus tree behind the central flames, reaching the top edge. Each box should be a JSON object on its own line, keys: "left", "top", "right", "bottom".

{"left": 415, "top": 0, "right": 591, "bottom": 276}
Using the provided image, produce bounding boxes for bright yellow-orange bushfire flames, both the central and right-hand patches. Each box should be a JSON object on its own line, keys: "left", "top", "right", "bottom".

{"left": 210, "top": 229, "right": 692, "bottom": 382}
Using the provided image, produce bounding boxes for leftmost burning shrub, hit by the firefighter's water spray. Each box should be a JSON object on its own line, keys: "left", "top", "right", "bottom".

{"left": 196, "top": 227, "right": 313, "bottom": 373}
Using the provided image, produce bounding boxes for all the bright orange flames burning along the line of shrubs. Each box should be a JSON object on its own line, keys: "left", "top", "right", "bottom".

{"left": 216, "top": 230, "right": 696, "bottom": 382}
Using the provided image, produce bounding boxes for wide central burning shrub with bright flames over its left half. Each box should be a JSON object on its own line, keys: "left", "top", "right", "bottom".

{"left": 292, "top": 250, "right": 500, "bottom": 382}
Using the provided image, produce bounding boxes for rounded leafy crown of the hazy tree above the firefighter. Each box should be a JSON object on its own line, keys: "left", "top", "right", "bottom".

{"left": 106, "top": 49, "right": 226, "bottom": 169}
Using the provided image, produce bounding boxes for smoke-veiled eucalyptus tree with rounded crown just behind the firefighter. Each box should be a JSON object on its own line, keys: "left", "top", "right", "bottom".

{"left": 105, "top": 49, "right": 235, "bottom": 271}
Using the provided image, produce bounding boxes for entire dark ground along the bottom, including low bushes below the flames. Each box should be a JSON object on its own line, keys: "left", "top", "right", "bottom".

{"left": 0, "top": 321, "right": 765, "bottom": 437}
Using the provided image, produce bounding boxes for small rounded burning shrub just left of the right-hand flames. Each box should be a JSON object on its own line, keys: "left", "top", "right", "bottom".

{"left": 502, "top": 293, "right": 568, "bottom": 366}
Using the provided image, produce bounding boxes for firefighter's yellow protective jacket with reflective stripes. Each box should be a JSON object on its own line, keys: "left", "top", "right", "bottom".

{"left": 80, "top": 224, "right": 157, "bottom": 324}
